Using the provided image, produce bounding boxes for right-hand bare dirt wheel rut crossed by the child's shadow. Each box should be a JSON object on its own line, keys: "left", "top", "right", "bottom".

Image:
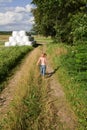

{"left": 42, "top": 45, "right": 77, "bottom": 130}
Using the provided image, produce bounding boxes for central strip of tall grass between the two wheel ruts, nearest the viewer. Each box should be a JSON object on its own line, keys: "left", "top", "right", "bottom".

{"left": 13, "top": 63, "right": 62, "bottom": 130}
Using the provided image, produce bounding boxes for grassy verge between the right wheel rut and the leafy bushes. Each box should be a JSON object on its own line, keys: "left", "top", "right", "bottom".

{"left": 47, "top": 44, "right": 87, "bottom": 130}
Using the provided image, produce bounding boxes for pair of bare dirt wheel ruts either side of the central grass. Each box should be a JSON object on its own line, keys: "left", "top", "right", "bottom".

{"left": 0, "top": 45, "right": 77, "bottom": 130}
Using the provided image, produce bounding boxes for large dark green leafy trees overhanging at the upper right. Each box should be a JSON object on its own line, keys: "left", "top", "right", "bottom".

{"left": 32, "top": 0, "right": 87, "bottom": 44}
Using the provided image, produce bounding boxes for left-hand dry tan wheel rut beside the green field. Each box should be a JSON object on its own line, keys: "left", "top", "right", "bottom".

{"left": 0, "top": 46, "right": 40, "bottom": 130}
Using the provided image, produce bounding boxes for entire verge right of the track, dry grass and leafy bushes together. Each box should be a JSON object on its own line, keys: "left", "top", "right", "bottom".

{"left": 47, "top": 44, "right": 87, "bottom": 130}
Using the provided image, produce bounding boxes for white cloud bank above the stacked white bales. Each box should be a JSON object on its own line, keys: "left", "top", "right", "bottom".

{"left": 0, "top": 4, "right": 34, "bottom": 30}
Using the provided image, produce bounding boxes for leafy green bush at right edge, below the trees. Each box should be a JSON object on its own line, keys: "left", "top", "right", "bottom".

{"left": 62, "top": 45, "right": 87, "bottom": 82}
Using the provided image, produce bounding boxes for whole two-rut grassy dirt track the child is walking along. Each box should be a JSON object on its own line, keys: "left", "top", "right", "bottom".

{"left": 0, "top": 37, "right": 86, "bottom": 130}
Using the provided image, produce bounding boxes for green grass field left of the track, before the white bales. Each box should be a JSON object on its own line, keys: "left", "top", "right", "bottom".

{"left": 0, "top": 46, "right": 32, "bottom": 91}
